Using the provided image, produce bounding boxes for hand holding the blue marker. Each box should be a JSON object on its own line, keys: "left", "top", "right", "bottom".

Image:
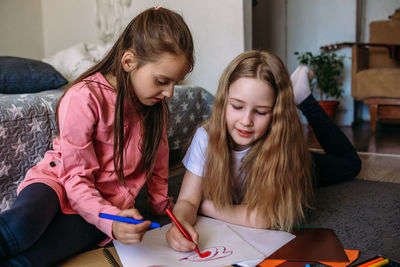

{"left": 112, "top": 209, "right": 151, "bottom": 245}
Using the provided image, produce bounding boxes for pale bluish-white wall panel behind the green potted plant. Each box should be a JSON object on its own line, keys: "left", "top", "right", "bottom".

{"left": 287, "top": 0, "right": 357, "bottom": 125}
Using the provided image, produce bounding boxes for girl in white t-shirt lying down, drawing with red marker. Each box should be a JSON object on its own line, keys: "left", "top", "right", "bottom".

{"left": 166, "top": 51, "right": 361, "bottom": 251}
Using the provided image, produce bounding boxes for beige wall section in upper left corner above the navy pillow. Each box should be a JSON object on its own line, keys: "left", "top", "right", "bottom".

{"left": 0, "top": 0, "right": 44, "bottom": 59}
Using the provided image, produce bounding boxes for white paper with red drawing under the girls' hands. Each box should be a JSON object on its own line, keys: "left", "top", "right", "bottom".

{"left": 114, "top": 216, "right": 294, "bottom": 267}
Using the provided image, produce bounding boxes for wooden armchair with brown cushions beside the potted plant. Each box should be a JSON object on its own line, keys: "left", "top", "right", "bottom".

{"left": 321, "top": 9, "right": 400, "bottom": 132}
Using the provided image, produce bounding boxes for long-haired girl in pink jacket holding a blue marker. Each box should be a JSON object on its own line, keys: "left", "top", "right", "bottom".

{"left": 0, "top": 7, "right": 194, "bottom": 266}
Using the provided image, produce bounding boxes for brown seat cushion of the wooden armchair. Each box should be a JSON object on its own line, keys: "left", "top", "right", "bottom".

{"left": 352, "top": 68, "right": 400, "bottom": 100}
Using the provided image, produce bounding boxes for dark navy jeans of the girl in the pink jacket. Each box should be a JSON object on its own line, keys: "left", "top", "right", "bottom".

{"left": 0, "top": 183, "right": 106, "bottom": 267}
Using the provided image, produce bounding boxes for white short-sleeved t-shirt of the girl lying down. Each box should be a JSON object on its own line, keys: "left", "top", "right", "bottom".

{"left": 182, "top": 127, "right": 249, "bottom": 199}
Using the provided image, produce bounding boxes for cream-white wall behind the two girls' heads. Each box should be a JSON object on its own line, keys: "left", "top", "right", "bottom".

{"left": 0, "top": 0, "right": 252, "bottom": 94}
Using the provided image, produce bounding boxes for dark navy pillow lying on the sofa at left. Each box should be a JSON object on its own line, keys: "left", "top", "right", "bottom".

{"left": 0, "top": 56, "right": 67, "bottom": 94}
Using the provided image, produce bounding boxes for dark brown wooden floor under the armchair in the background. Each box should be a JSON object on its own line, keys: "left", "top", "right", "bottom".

{"left": 307, "top": 122, "right": 400, "bottom": 155}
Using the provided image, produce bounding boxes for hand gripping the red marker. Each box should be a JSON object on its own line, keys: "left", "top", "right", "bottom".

{"left": 166, "top": 221, "right": 199, "bottom": 251}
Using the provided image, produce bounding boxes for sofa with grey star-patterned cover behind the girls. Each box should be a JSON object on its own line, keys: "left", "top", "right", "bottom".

{"left": 0, "top": 85, "right": 214, "bottom": 211}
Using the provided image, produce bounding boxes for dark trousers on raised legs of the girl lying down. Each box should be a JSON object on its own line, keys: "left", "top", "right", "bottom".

{"left": 298, "top": 95, "right": 361, "bottom": 186}
